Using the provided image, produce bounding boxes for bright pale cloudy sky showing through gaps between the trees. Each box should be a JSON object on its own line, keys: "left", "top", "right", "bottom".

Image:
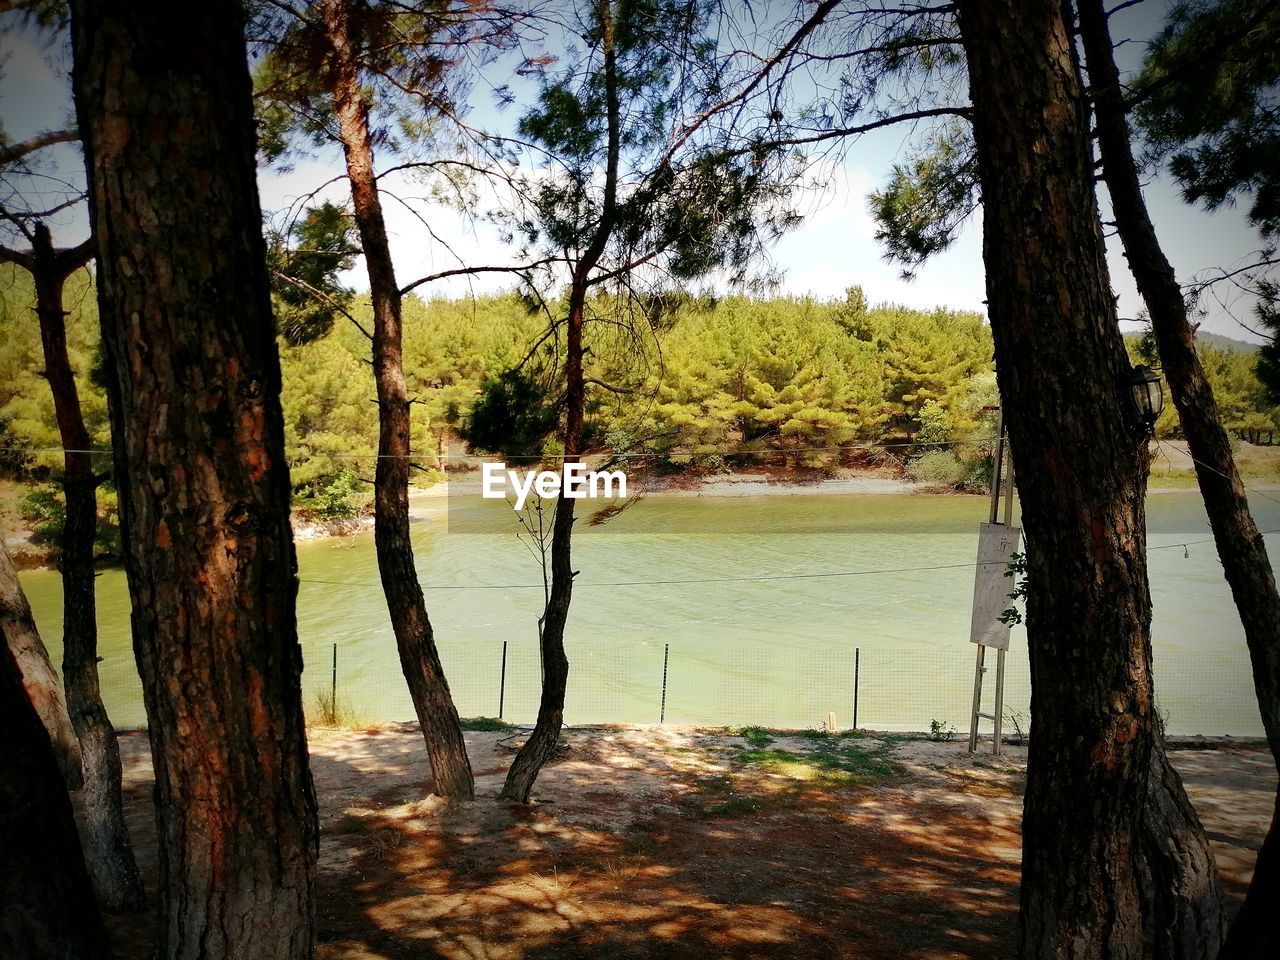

{"left": 0, "top": 0, "right": 1257, "bottom": 339}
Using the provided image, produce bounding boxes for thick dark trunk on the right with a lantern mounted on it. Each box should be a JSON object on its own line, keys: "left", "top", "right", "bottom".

{"left": 959, "top": 0, "right": 1155, "bottom": 960}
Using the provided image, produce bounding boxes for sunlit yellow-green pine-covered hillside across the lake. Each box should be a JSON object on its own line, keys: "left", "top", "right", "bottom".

{"left": 0, "top": 270, "right": 1280, "bottom": 535}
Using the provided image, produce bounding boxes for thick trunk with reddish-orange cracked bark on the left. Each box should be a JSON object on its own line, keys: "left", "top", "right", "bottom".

{"left": 72, "top": 0, "right": 317, "bottom": 960}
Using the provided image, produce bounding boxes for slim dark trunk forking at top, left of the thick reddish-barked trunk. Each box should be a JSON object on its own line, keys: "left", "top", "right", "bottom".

{"left": 32, "top": 224, "right": 146, "bottom": 910}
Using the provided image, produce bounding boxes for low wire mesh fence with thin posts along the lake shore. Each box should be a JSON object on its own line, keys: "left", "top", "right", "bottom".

{"left": 100, "top": 636, "right": 1262, "bottom": 737}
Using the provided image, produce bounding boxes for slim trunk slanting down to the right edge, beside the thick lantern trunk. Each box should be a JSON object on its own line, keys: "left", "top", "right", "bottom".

{"left": 1079, "top": 0, "right": 1280, "bottom": 957}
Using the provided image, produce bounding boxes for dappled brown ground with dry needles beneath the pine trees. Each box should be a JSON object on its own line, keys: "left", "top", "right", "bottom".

{"left": 94, "top": 724, "right": 1276, "bottom": 960}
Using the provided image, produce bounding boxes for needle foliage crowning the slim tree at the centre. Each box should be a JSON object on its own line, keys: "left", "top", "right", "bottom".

{"left": 509, "top": 0, "right": 799, "bottom": 280}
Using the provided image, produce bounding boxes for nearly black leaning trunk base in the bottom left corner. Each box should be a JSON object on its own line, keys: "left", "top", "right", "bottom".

{"left": 0, "top": 634, "right": 109, "bottom": 960}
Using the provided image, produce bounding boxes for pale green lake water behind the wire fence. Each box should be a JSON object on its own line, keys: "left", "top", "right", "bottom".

{"left": 22, "top": 492, "right": 1280, "bottom": 736}
